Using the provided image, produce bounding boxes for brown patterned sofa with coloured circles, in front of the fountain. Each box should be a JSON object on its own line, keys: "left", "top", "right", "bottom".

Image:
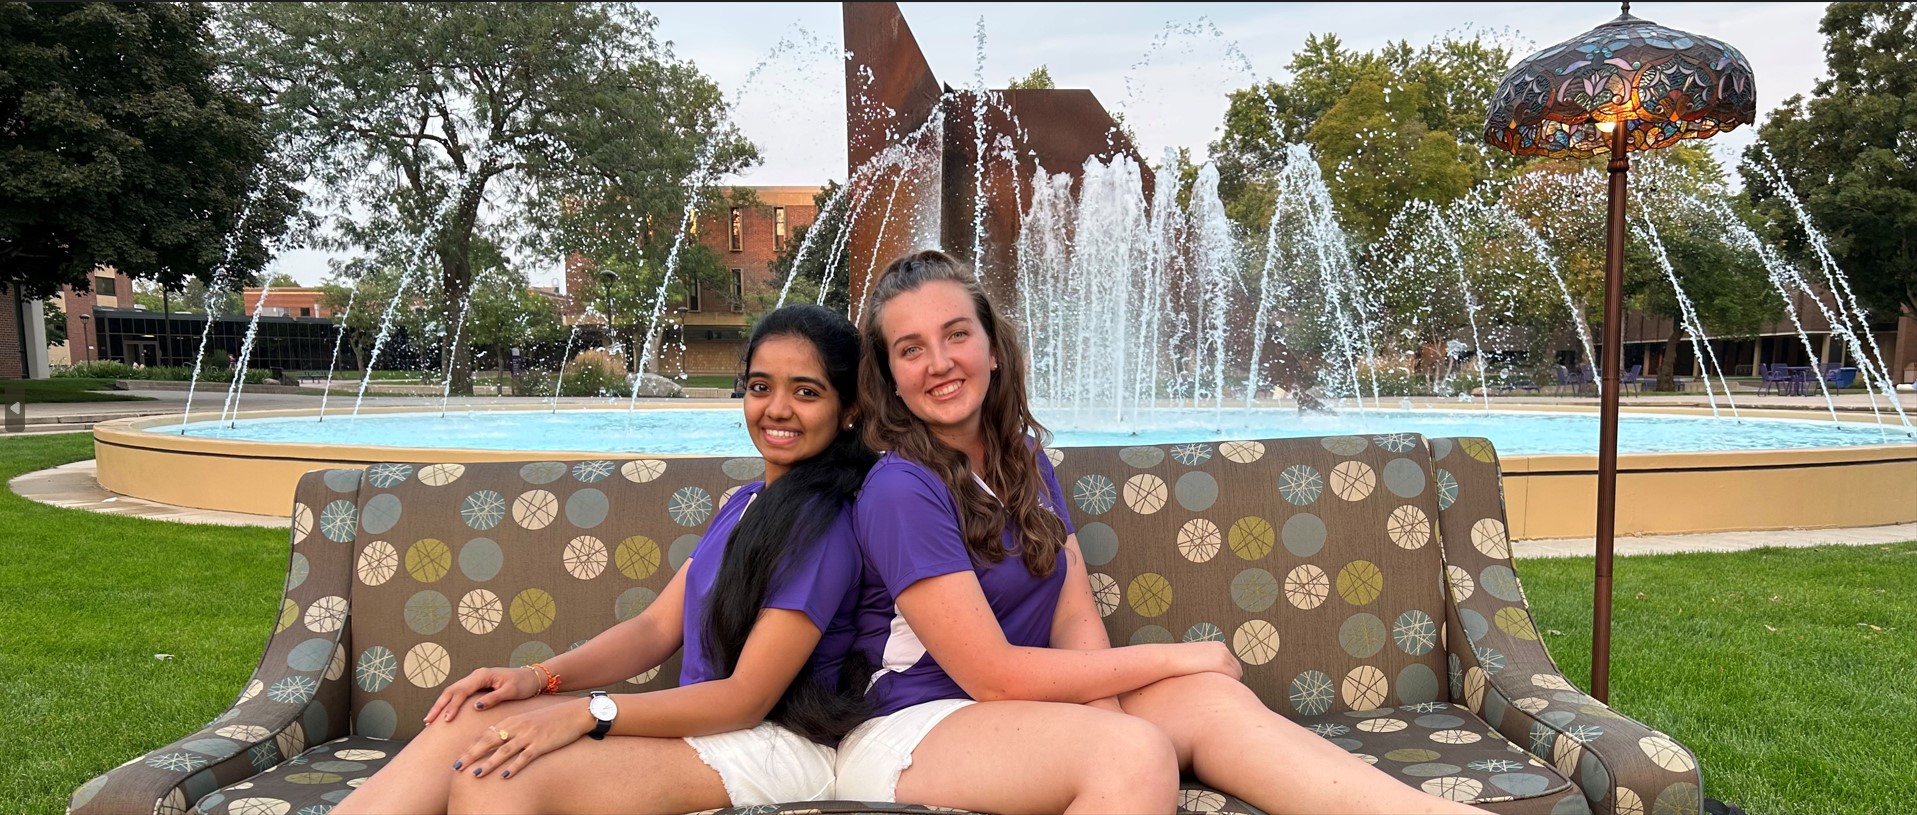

{"left": 71, "top": 435, "right": 1702, "bottom": 815}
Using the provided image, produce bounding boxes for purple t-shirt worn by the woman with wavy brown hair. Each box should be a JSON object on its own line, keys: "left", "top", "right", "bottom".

{"left": 853, "top": 444, "right": 1072, "bottom": 715}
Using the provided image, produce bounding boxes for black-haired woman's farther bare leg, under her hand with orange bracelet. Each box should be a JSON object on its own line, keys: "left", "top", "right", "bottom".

{"left": 330, "top": 696, "right": 577, "bottom": 815}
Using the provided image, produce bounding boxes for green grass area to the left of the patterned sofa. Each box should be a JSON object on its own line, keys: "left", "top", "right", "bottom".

{"left": 0, "top": 433, "right": 288, "bottom": 813}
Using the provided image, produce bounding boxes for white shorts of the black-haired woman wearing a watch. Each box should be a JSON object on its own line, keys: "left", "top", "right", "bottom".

{"left": 686, "top": 721, "right": 836, "bottom": 807}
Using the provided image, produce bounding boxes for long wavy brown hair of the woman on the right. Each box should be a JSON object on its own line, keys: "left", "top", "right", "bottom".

{"left": 859, "top": 249, "right": 1066, "bottom": 577}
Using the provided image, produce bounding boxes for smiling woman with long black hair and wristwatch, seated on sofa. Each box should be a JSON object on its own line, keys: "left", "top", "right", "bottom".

{"left": 334, "top": 305, "right": 874, "bottom": 815}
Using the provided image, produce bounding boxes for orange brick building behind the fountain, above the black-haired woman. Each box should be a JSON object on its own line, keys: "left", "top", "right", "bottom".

{"left": 564, "top": 186, "right": 819, "bottom": 376}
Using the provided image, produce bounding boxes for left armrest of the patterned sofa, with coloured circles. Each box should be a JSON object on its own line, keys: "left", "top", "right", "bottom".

{"left": 67, "top": 470, "right": 360, "bottom": 813}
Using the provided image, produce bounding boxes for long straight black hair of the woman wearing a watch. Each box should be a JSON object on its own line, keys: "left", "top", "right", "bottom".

{"left": 705, "top": 305, "right": 878, "bottom": 744}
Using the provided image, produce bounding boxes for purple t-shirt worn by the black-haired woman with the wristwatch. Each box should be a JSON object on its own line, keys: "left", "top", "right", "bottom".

{"left": 679, "top": 481, "right": 859, "bottom": 688}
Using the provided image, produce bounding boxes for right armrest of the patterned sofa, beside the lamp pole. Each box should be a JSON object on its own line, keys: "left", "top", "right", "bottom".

{"left": 1428, "top": 439, "right": 1702, "bottom": 815}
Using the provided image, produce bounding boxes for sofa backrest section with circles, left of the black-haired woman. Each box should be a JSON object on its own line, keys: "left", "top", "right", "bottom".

{"left": 351, "top": 458, "right": 765, "bottom": 738}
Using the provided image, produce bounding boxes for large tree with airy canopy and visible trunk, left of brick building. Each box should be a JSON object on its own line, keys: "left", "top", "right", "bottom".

{"left": 226, "top": 4, "right": 757, "bottom": 393}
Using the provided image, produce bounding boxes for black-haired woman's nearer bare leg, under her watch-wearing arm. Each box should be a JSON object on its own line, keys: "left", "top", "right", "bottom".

{"left": 440, "top": 736, "right": 730, "bottom": 815}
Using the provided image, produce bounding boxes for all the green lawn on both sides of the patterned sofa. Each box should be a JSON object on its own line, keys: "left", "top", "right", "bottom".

{"left": 0, "top": 433, "right": 1917, "bottom": 815}
